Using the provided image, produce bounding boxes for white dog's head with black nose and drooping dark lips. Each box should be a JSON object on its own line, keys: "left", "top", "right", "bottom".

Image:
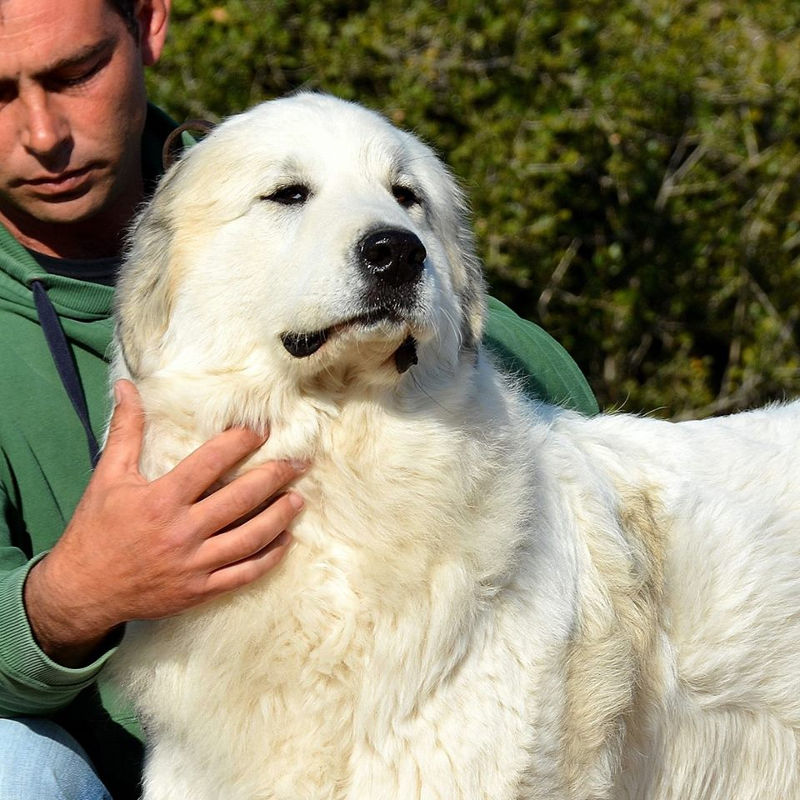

{"left": 117, "top": 94, "right": 484, "bottom": 396}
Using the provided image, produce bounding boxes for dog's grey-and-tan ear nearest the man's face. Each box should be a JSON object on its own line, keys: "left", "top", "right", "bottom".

{"left": 115, "top": 162, "right": 182, "bottom": 378}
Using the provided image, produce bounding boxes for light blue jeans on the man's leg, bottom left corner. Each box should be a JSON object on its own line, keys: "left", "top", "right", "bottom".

{"left": 0, "top": 717, "right": 111, "bottom": 800}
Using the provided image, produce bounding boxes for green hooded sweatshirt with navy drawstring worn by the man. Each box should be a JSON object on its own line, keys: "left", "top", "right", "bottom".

{"left": 0, "top": 107, "right": 597, "bottom": 800}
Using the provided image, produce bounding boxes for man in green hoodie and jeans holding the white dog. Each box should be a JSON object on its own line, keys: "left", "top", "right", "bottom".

{"left": 0, "top": 0, "right": 596, "bottom": 800}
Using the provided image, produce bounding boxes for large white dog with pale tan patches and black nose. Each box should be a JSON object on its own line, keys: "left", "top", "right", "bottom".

{"left": 115, "top": 90, "right": 800, "bottom": 800}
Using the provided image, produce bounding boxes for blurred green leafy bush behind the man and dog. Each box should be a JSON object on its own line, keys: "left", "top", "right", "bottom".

{"left": 149, "top": 0, "right": 800, "bottom": 417}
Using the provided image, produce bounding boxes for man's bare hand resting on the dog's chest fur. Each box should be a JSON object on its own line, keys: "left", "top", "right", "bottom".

{"left": 25, "top": 381, "right": 302, "bottom": 666}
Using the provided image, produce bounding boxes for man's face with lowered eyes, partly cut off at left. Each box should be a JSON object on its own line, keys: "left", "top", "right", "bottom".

{"left": 0, "top": 0, "right": 166, "bottom": 255}
